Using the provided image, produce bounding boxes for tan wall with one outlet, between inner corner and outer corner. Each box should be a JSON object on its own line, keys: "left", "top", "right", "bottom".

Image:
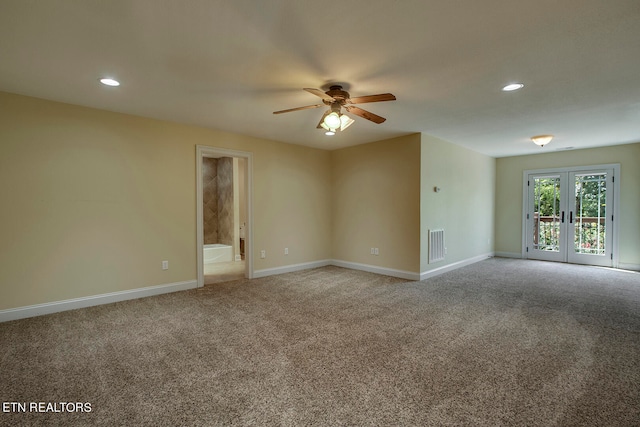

{"left": 331, "top": 134, "right": 420, "bottom": 273}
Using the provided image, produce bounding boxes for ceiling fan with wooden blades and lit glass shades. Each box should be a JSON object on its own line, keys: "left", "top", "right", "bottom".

{"left": 273, "top": 85, "right": 396, "bottom": 135}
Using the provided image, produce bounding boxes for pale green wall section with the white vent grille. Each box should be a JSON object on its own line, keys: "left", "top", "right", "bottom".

{"left": 420, "top": 134, "right": 495, "bottom": 272}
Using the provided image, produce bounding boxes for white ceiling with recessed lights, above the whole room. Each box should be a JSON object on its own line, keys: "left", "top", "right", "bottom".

{"left": 0, "top": 0, "right": 640, "bottom": 157}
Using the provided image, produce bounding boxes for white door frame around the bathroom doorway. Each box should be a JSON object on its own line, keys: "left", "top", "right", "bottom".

{"left": 196, "top": 145, "right": 253, "bottom": 288}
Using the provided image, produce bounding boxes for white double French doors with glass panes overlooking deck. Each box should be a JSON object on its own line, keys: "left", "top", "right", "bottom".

{"left": 524, "top": 166, "right": 616, "bottom": 267}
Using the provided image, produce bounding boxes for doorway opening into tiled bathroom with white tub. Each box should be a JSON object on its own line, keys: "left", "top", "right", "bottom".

{"left": 196, "top": 145, "right": 253, "bottom": 287}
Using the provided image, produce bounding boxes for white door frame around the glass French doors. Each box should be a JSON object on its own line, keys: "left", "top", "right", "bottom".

{"left": 521, "top": 163, "right": 620, "bottom": 268}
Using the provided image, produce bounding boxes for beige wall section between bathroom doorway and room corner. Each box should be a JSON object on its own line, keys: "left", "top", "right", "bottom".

{"left": 253, "top": 139, "right": 331, "bottom": 270}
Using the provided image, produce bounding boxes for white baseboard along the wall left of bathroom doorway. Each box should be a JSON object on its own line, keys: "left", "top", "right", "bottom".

{"left": 0, "top": 280, "right": 198, "bottom": 322}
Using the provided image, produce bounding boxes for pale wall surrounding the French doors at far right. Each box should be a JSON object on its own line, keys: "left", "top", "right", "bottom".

{"left": 495, "top": 143, "right": 640, "bottom": 268}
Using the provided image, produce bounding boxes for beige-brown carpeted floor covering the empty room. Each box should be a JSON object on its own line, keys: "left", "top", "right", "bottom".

{"left": 0, "top": 258, "right": 640, "bottom": 426}
